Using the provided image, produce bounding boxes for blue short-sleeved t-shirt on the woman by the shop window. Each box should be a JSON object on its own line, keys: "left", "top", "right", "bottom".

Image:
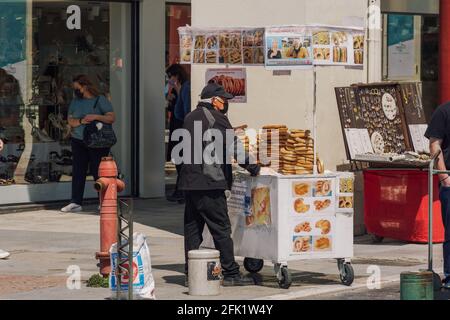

{"left": 69, "top": 96, "right": 113, "bottom": 140}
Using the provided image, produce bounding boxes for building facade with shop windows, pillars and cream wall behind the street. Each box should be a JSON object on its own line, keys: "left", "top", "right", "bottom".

{"left": 0, "top": 0, "right": 450, "bottom": 205}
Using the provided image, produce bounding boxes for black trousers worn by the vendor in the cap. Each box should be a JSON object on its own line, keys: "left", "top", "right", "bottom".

{"left": 184, "top": 190, "right": 239, "bottom": 276}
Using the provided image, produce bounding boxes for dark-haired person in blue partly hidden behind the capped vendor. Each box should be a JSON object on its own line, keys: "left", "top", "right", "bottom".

{"left": 166, "top": 64, "right": 191, "bottom": 203}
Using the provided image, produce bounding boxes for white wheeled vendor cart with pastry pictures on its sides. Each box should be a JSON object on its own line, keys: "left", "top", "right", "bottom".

{"left": 204, "top": 173, "right": 354, "bottom": 289}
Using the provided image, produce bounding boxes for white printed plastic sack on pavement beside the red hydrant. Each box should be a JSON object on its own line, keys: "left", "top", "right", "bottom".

{"left": 109, "top": 233, "right": 156, "bottom": 300}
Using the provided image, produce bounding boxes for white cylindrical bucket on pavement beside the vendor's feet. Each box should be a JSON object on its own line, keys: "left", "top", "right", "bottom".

{"left": 188, "top": 250, "right": 222, "bottom": 296}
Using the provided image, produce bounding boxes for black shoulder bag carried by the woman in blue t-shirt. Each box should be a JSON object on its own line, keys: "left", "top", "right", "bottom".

{"left": 83, "top": 98, "right": 117, "bottom": 149}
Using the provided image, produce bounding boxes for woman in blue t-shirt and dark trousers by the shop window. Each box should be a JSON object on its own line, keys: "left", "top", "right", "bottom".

{"left": 61, "top": 75, "right": 116, "bottom": 212}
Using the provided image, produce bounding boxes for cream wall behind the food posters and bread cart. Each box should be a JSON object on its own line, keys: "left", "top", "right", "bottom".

{"left": 192, "top": 0, "right": 367, "bottom": 170}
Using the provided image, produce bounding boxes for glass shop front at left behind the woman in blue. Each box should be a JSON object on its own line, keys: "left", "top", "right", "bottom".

{"left": 0, "top": 1, "right": 132, "bottom": 205}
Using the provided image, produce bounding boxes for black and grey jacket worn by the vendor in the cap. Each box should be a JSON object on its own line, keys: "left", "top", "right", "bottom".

{"left": 178, "top": 102, "right": 261, "bottom": 191}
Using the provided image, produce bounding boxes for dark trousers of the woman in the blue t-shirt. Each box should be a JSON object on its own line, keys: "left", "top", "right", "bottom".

{"left": 72, "top": 139, "right": 110, "bottom": 206}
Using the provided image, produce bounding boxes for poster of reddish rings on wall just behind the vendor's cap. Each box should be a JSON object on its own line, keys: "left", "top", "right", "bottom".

{"left": 206, "top": 68, "right": 247, "bottom": 103}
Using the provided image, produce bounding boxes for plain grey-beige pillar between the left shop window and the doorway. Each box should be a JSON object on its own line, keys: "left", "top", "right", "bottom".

{"left": 139, "top": 0, "right": 166, "bottom": 198}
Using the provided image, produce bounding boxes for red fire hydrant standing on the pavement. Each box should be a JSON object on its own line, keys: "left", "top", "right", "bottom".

{"left": 94, "top": 157, "right": 125, "bottom": 277}
